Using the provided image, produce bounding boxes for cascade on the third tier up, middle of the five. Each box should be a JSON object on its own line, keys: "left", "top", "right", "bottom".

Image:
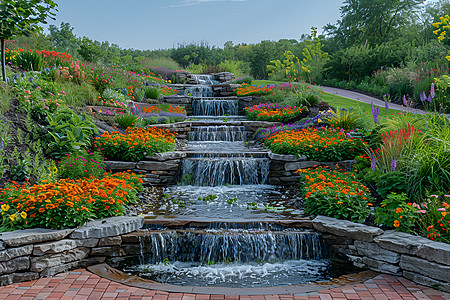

{"left": 189, "top": 125, "right": 246, "bottom": 142}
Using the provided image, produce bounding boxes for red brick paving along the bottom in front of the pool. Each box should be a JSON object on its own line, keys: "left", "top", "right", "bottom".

{"left": 0, "top": 269, "right": 450, "bottom": 300}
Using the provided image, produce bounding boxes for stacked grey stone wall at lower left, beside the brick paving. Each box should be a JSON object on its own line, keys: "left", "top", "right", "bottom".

{"left": 0, "top": 217, "right": 144, "bottom": 285}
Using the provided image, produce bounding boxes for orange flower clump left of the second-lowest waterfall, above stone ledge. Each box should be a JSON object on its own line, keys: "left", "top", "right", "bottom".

{"left": 94, "top": 127, "right": 175, "bottom": 161}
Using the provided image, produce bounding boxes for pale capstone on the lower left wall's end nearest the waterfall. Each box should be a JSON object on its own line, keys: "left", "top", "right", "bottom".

{"left": 70, "top": 217, "right": 144, "bottom": 239}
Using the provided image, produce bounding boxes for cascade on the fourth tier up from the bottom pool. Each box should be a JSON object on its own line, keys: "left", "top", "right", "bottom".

{"left": 192, "top": 98, "right": 239, "bottom": 116}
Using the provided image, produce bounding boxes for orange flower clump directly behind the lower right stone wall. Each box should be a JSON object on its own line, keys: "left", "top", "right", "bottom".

{"left": 297, "top": 168, "right": 373, "bottom": 223}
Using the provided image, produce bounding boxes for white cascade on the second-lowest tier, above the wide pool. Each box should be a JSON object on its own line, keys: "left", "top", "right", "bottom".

{"left": 182, "top": 154, "right": 270, "bottom": 186}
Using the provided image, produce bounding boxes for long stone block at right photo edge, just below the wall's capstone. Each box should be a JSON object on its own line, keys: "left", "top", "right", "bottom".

{"left": 400, "top": 254, "right": 450, "bottom": 283}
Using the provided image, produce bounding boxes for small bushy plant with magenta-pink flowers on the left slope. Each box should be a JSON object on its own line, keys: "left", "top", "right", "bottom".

{"left": 59, "top": 150, "right": 105, "bottom": 179}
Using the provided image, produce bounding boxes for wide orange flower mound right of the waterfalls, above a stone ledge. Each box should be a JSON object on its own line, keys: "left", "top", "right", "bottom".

{"left": 264, "top": 127, "right": 365, "bottom": 161}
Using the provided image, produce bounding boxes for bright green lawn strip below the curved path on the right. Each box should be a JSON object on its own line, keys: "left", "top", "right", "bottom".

{"left": 321, "top": 93, "right": 408, "bottom": 122}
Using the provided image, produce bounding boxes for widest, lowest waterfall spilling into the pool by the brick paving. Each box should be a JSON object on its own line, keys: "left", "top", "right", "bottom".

{"left": 139, "top": 230, "right": 330, "bottom": 264}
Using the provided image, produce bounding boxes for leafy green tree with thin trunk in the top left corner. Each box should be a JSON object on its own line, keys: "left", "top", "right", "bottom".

{"left": 0, "top": 0, "right": 57, "bottom": 81}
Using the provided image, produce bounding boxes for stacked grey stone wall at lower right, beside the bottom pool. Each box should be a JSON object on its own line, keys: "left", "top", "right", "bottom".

{"left": 313, "top": 216, "right": 450, "bottom": 292}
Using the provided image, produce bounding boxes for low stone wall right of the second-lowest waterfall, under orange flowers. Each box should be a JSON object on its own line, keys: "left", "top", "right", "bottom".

{"left": 269, "top": 152, "right": 356, "bottom": 185}
